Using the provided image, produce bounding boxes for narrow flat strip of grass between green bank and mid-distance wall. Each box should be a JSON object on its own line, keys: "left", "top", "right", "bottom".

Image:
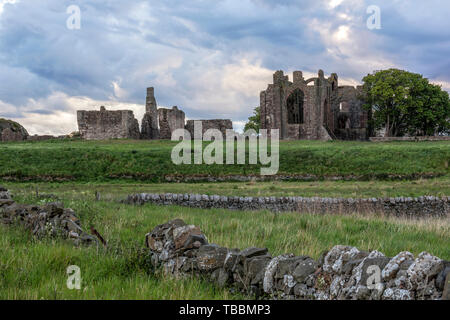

{"left": 3, "top": 176, "right": 450, "bottom": 200}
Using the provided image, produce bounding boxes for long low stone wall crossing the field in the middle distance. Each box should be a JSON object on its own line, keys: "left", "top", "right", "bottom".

{"left": 125, "top": 193, "right": 450, "bottom": 217}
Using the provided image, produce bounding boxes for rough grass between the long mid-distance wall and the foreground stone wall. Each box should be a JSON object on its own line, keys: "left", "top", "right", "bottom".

{"left": 0, "top": 192, "right": 450, "bottom": 299}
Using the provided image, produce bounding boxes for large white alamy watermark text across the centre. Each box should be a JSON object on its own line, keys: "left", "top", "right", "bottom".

{"left": 171, "top": 121, "right": 280, "bottom": 175}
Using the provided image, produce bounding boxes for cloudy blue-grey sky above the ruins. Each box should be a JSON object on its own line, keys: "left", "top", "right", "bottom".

{"left": 0, "top": 0, "right": 450, "bottom": 134}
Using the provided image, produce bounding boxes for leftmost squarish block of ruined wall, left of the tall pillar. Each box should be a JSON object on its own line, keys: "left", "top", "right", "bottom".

{"left": 77, "top": 107, "right": 140, "bottom": 140}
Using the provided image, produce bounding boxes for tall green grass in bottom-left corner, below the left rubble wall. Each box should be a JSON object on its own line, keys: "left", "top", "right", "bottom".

{"left": 0, "top": 225, "right": 243, "bottom": 300}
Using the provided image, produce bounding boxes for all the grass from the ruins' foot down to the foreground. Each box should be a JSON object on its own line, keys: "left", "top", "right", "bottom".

{"left": 0, "top": 140, "right": 450, "bottom": 299}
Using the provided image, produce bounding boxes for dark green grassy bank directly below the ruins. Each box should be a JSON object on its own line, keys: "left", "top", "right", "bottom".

{"left": 0, "top": 140, "right": 450, "bottom": 182}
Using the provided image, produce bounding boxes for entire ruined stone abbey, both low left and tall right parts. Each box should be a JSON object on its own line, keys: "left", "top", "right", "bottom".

{"left": 77, "top": 70, "right": 370, "bottom": 140}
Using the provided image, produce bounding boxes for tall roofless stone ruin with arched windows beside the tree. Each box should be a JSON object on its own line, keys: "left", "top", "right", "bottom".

{"left": 260, "top": 70, "right": 369, "bottom": 140}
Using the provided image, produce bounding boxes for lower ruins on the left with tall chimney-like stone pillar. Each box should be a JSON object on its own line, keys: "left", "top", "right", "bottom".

{"left": 77, "top": 87, "right": 233, "bottom": 140}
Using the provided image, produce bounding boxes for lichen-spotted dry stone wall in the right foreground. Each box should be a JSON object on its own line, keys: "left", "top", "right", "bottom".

{"left": 146, "top": 219, "right": 450, "bottom": 300}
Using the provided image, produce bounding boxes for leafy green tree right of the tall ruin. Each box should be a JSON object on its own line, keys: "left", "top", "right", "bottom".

{"left": 363, "top": 69, "right": 450, "bottom": 137}
